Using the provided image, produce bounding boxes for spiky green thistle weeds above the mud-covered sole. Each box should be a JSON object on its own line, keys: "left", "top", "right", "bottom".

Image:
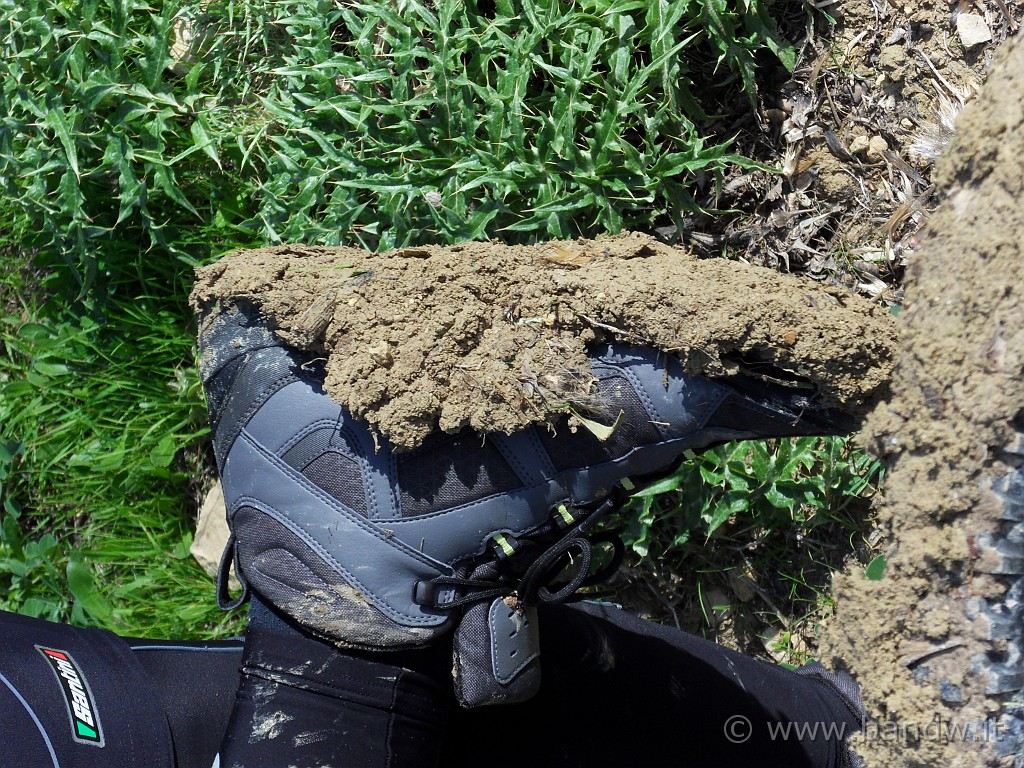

{"left": 0, "top": 0, "right": 793, "bottom": 291}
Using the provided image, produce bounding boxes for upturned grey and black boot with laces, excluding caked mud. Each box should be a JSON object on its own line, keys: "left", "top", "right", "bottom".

{"left": 200, "top": 309, "right": 852, "bottom": 707}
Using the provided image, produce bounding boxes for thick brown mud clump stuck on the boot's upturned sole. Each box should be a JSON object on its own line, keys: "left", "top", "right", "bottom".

{"left": 193, "top": 233, "right": 895, "bottom": 447}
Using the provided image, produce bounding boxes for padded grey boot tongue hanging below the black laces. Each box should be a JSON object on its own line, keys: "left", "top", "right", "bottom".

{"left": 453, "top": 597, "right": 541, "bottom": 709}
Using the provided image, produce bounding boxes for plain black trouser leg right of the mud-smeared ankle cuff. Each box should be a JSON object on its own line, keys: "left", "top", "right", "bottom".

{"left": 442, "top": 603, "right": 860, "bottom": 768}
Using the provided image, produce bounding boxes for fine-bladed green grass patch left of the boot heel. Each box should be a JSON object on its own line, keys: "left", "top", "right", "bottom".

{"left": 0, "top": 225, "right": 238, "bottom": 637}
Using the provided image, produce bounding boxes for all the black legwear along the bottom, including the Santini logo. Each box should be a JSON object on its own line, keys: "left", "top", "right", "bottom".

{"left": 0, "top": 603, "right": 859, "bottom": 768}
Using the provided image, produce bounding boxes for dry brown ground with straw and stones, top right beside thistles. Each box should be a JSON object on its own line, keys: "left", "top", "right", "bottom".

{"left": 696, "top": 0, "right": 1024, "bottom": 304}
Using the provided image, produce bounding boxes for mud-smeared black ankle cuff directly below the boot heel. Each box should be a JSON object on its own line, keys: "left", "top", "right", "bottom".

{"left": 220, "top": 600, "right": 452, "bottom": 768}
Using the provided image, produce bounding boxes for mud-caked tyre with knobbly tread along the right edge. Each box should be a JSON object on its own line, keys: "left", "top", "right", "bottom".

{"left": 823, "top": 41, "right": 1024, "bottom": 768}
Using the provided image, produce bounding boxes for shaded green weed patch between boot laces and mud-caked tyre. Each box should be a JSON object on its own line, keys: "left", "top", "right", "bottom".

{"left": 602, "top": 437, "right": 882, "bottom": 664}
